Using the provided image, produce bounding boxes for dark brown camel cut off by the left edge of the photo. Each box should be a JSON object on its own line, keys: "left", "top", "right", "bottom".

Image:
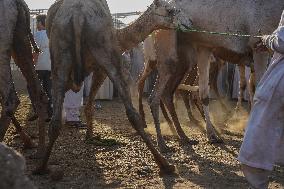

{"left": 0, "top": 0, "right": 48, "bottom": 156}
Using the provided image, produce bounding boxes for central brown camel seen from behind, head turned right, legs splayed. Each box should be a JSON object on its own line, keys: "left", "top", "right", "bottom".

{"left": 35, "top": 0, "right": 191, "bottom": 173}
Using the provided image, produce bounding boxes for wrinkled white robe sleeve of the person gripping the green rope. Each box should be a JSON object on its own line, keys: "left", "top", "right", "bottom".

{"left": 264, "top": 26, "right": 284, "bottom": 54}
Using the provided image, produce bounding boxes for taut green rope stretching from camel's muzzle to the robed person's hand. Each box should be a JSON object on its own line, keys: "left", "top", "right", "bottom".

{"left": 177, "top": 26, "right": 263, "bottom": 38}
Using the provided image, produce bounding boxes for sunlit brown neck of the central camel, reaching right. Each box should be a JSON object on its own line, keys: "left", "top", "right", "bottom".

{"left": 117, "top": 8, "right": 158, "bottom": 52}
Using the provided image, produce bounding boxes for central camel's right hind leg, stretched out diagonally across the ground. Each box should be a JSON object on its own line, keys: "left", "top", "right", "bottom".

{"left": 91, "top": 47, "right": 175, "bottom": 174}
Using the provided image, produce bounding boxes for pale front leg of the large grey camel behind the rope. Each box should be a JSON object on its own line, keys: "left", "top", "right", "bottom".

{"left": 197, "top": 48, "right": 222, "bottom": 143}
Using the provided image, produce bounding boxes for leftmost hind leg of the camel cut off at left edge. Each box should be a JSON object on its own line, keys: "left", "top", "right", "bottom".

{"left": 0, "top": 8, "right": 20, "bottom": 142}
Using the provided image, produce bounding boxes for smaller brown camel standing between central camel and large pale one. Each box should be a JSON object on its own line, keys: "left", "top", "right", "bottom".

{"left": 138, "top": 30, "right": 221, "bottom": 149}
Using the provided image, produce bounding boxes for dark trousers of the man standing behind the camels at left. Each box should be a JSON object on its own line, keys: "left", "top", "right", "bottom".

{"left": 28, "top": 70, "right": 52, "bottom": 116}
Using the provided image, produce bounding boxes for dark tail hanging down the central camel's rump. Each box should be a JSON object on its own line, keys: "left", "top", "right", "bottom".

{"left": 73, "top": 12, "right": 85, "bottom": 86}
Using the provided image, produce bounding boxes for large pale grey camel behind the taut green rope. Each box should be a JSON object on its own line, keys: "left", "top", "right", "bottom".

{"left": 137, "top": 0, "right": 284, "bottom": 145}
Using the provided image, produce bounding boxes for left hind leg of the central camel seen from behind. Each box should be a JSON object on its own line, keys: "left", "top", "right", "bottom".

{"left": 34, "top": 32, "right": 72, "bottom": 174}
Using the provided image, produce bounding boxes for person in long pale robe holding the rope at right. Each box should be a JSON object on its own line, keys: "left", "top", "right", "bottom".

{"left": 238, "top": 11, "right": 284, "bottom": 189}
